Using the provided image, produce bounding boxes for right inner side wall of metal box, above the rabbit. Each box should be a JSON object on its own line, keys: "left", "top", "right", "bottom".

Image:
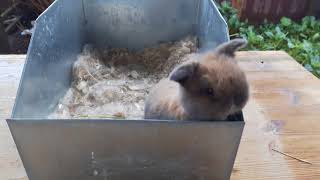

{"left": 197, "top": 0, "right": 229, "bottom": 51}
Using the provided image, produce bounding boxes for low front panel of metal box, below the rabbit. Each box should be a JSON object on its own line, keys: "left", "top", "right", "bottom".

{"left": 8, "top": 120, "right": 244, "bottom": 180}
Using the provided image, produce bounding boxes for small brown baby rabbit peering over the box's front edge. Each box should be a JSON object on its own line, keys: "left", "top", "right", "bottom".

{"left": 144, "top": 39, "right": 249, "bottom": 120}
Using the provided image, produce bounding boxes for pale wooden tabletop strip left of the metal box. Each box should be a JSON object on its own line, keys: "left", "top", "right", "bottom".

{"left": 0, "top": 55, "right": 28, "bottom": 180}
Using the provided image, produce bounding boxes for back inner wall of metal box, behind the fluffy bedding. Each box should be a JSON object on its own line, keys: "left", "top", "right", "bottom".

{"left": 84, "top": 0, "right": 200, "bottom": 50}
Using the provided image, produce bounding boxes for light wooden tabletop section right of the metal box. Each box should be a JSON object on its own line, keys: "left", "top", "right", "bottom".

{"left": 231, "top": 52, "right": 320, "bottom": 180}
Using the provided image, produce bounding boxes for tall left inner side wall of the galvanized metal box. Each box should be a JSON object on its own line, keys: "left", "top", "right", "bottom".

{"left": 12, "top": 0, "right": 85, "bottom": 118}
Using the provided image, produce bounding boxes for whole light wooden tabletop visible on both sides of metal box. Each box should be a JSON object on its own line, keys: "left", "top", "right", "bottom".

{"left": 0, "top": 51, "right": 320, "bottom": 180}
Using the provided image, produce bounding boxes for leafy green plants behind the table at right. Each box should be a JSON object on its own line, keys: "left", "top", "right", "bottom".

{"left": 219, "top": 1, "right": 320, "bottom": 77}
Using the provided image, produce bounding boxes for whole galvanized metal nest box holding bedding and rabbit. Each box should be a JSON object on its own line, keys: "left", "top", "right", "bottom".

{"left": 7, "top": 0, "right": 244, "bottom": 180}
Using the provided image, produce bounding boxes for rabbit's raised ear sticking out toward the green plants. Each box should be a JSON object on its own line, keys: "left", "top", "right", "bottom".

{"left": 215, "top": 39, "right": 248, "bottom": 57}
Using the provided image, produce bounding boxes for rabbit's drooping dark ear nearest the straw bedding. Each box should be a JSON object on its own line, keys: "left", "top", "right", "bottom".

{"left": 169, "top": 62, "right": 199, "bottom": 85}
